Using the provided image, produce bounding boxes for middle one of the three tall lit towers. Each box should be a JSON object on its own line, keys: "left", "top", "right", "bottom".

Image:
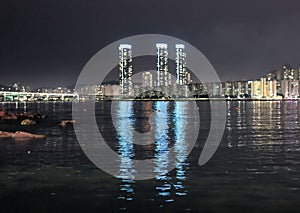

{"left": 156, "top": 43, "right": 169, "bottom": 87}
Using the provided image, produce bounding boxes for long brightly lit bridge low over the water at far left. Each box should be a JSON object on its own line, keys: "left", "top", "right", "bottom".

{"left": 0, "top": 91, "right": 78, "bottom": 101}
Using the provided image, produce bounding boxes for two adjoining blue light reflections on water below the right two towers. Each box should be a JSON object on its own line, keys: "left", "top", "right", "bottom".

{"left": 154, "top": 102, "right": 188, "bottom": 202}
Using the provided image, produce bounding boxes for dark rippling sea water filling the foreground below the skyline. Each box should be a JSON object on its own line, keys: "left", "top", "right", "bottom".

{"left": 0, "top": 101, "right": 300, "bottom": 212}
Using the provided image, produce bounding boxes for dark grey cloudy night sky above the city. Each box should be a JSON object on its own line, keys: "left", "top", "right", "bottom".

{"left": 0, "top": 0, "right": 300, "bottom": 88}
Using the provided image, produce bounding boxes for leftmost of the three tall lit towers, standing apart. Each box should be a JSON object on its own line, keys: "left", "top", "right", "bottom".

{"left": 119, "top": 44, "right": 132, "bottom": 96}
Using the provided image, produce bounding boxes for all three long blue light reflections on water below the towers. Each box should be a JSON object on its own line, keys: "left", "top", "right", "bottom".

{"left": 115, "top": 101, "right": 188, "bottom": 206}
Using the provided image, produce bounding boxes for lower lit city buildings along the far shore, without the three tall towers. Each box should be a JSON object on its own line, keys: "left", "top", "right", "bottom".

{"left": 0, "top": 64, "right": 300, "bottom": 97}
